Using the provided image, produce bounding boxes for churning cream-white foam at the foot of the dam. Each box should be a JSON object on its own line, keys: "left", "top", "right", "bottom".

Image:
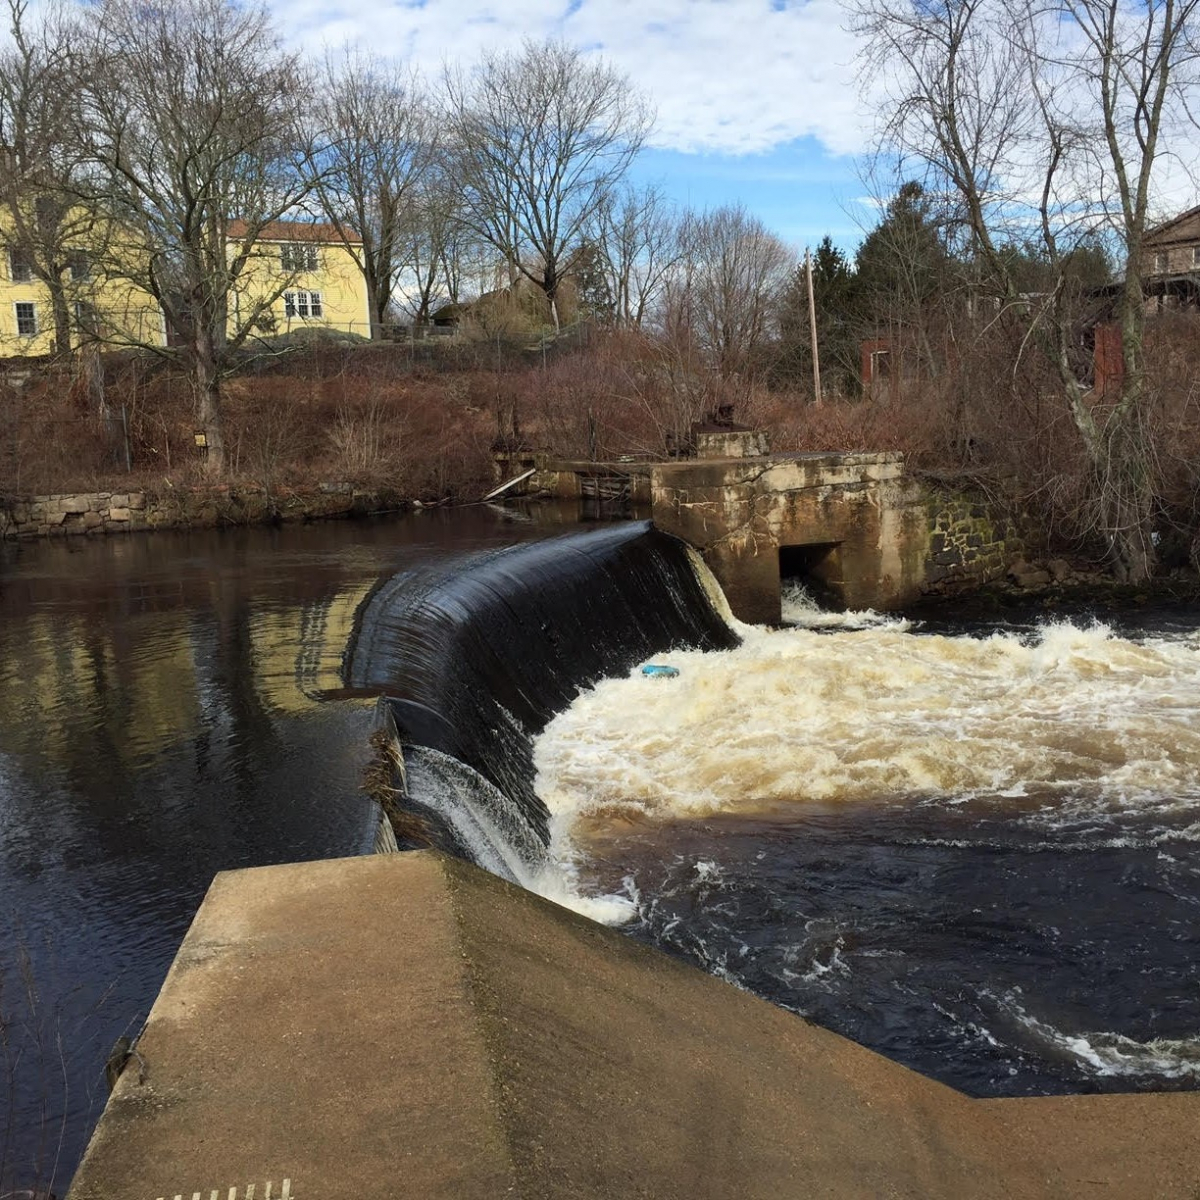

{"left": 534, "top": 622, "right": 1200, "bottom": 836}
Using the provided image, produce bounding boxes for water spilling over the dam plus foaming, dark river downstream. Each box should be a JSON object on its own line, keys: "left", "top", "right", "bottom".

{"left": 347, "top": 526, "right": 1200, "bottom": 1096}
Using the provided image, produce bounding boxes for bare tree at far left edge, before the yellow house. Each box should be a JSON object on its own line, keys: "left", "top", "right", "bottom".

{"left": 0, "top": 0, "right": 103, "bottom": 355}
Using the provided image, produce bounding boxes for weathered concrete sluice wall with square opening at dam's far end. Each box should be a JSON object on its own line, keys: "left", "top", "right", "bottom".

{"left": 652, "top": 452, "right": 929, "bottom": 623}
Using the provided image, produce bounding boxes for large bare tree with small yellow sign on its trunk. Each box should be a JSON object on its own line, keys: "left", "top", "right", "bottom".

{"left": 84, "top": 0, "right": 324, "bottom": 475}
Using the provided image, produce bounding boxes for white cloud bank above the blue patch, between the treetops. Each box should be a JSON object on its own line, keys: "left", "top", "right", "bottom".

{"left": 275, "top": 0, "right": 866, "bottom": 155}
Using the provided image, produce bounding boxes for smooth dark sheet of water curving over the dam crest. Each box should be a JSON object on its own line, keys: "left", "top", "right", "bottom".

{"left": 346, "top": 522, "right": 740, "bottom": 854}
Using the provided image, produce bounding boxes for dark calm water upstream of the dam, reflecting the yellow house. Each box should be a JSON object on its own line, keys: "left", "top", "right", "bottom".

{"left": 0, "top": 509, "right": 580, "bottom": 1195}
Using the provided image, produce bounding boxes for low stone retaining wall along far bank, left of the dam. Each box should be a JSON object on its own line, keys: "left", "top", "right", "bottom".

{"left": 0, "top": 484, "right": 403, "bottom": 539}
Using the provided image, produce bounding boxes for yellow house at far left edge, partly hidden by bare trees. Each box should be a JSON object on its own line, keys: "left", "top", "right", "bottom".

{"left": 0, "top": 222, "right": 166, "bottom": 358}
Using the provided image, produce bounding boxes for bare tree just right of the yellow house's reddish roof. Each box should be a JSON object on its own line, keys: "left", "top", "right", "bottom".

{"left": 318, "top": 49, "right": 436, "bottom": 338}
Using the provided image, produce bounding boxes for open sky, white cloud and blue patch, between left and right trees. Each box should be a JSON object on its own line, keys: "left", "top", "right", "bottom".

{"left": 278, "top": 0, "right": 872, "bottom": 250}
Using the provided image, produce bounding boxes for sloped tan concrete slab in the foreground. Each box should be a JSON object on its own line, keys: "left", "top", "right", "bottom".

{"left": 68, "top": 853, "right": 1200, "bottom": 1200}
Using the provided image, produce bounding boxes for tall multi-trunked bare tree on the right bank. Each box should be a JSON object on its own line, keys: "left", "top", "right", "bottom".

{"left": 858, "top": 0, "right": 1198, "bottom": 580}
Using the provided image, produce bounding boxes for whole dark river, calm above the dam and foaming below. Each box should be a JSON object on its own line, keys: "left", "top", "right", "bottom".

{"left": 0, "top": 509, "right": 1200, "bottom": 1194}
